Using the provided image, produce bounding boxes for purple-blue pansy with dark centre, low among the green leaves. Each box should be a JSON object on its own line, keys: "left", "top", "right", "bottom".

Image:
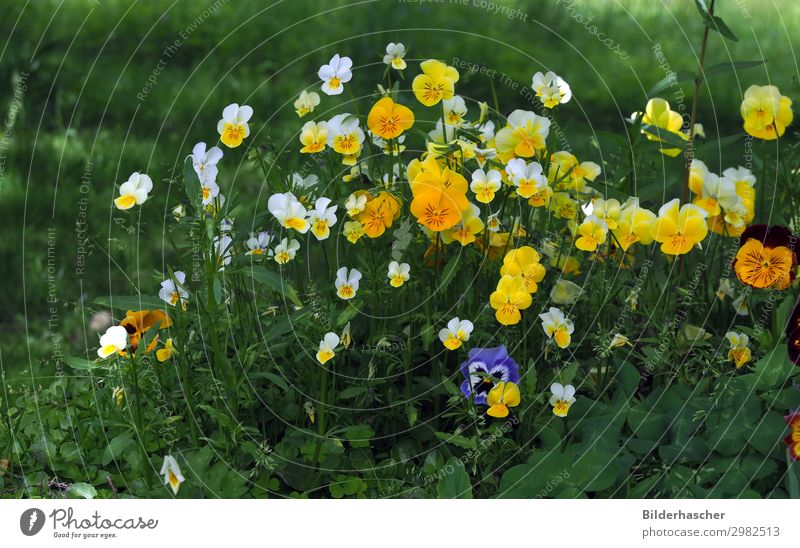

{"left": 461, "top": 345, "right": 519, "bottom": 405}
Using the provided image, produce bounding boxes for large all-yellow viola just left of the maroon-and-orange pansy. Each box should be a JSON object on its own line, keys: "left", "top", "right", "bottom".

{"left": 650, "top": 198, "right": 708, "bottom": 255}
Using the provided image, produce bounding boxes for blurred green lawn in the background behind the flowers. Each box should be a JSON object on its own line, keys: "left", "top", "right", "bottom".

{"left": 0, "top": 0, "right": 800, "bottom": 368}
